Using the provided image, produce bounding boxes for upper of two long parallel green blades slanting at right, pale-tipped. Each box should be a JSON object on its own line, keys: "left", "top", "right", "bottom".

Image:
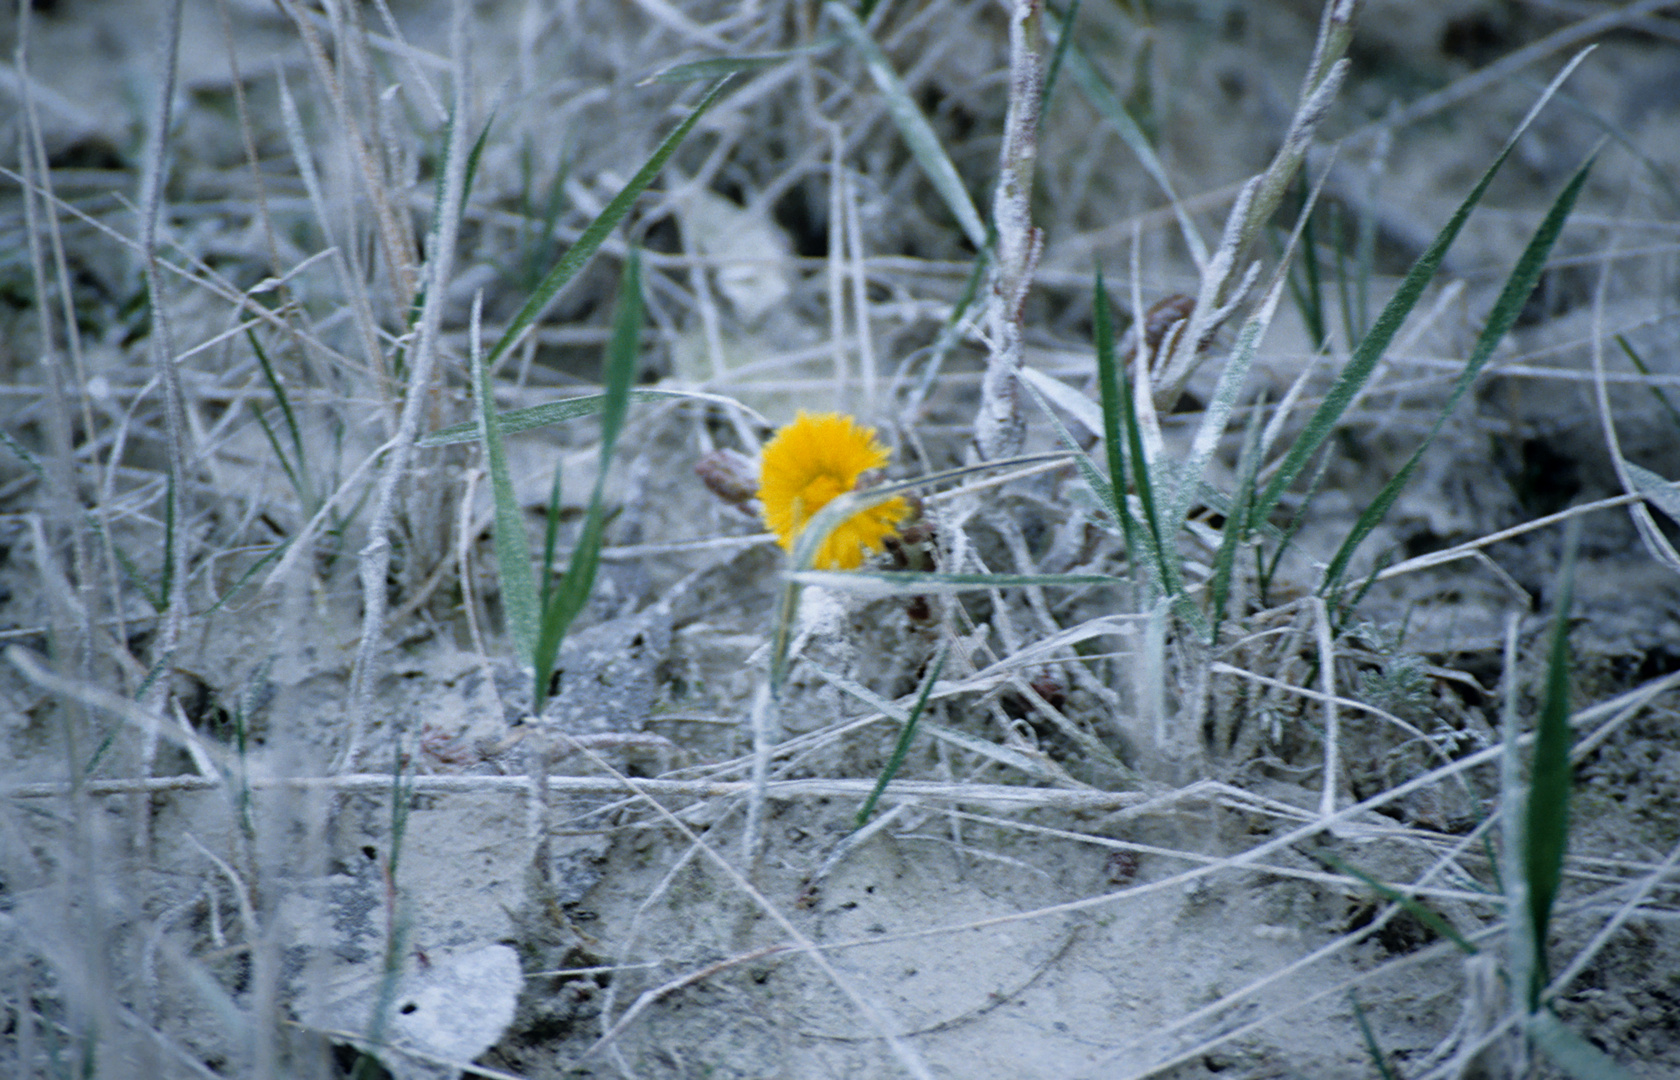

{"left": 1250, "top": 52, "right": 1586, "bottom": 526}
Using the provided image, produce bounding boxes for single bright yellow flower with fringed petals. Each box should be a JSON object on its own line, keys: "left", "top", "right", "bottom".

{"left": 758, "top": 408, "right": 911, "bottom": 569}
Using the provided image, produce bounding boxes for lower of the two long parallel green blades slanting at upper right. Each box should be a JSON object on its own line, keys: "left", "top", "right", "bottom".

{"left": 1319, "top": 158, "right": 1594, "bottom": 593}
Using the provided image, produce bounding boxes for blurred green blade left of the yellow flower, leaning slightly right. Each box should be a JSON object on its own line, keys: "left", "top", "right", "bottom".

{"left": 531, "top": 247, "right": 642, "bottom": 710}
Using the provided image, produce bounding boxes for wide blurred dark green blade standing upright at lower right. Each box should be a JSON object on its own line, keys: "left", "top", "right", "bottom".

{"left": 1522, "top": 517, "right": 1581, "bottom": 1013}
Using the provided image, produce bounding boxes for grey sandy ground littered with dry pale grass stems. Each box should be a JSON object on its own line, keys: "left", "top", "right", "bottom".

{"left": 0, "top": 0, "right": 1680, "bottom": 1080}
